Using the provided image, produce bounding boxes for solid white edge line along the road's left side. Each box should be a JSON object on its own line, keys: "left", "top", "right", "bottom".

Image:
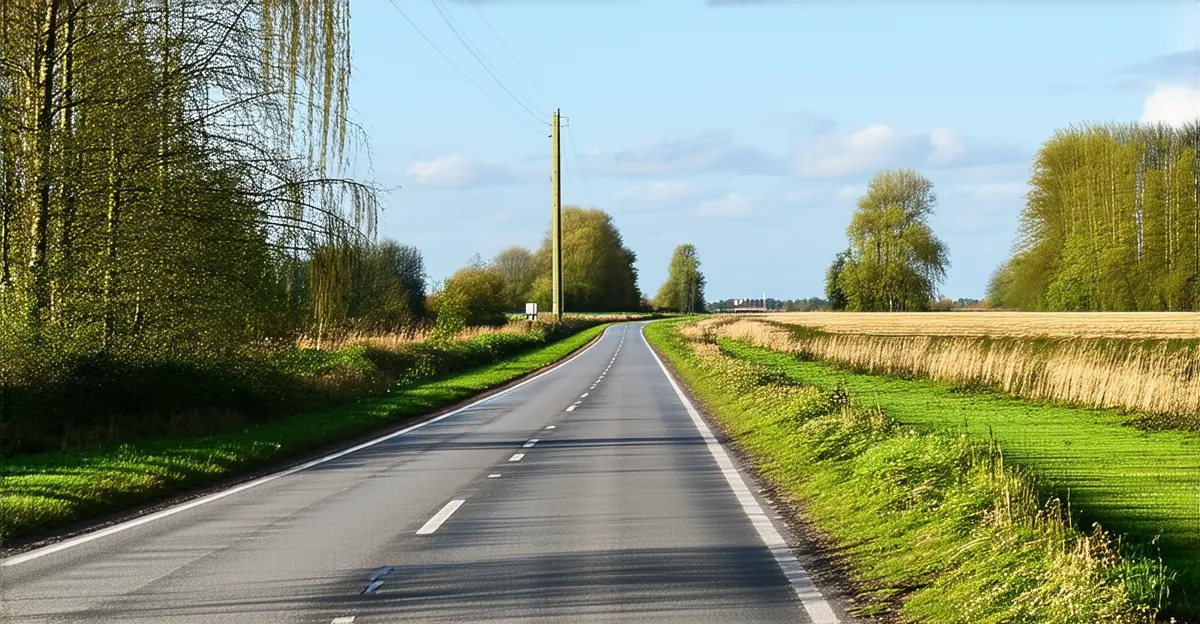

{"left": 0, "top": 329, "right": 608, "bottom": 568}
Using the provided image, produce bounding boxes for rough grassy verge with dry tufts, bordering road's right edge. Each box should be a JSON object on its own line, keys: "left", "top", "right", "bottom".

{"left": 647, "top": 323, "right": 1165, "bottom": 623}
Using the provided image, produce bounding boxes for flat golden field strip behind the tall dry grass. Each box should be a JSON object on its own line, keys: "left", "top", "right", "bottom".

{"left": 755, "top": 312, "right": 1200, "bottom": 340}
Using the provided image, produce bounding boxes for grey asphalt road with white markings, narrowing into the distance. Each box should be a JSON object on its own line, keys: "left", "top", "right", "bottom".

{"left": 0, "top": 324, "right": 845, "bottom": 624}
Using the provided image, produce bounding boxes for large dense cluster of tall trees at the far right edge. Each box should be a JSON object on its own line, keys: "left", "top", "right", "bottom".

{"left": 986, "top": 124, "right": 1200, "bottom": 311}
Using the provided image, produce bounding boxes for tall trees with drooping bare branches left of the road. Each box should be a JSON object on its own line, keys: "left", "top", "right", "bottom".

{"left": 0, "top": 0, "right": 377, "bottom": 364}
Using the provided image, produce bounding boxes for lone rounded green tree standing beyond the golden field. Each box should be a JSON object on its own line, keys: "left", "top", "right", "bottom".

{"left": 826, "top": 169, "right": 949, "bottom": 312}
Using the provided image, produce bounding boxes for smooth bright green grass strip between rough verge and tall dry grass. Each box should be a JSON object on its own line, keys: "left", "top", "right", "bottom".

{"left": 722, "top": 341, "right": 1200, "bottom": 617}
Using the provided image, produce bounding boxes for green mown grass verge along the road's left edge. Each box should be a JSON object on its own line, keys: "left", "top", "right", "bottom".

{"left": 0, "top": 325, "right": 606, "bottom": 544}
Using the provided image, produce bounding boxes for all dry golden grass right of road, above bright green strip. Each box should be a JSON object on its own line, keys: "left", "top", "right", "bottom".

{"left": 696, "top": 313, "right": 1200, "bottom": 428}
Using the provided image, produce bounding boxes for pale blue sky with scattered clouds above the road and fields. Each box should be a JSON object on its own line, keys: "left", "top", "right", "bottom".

{"left": 352, "top": 0, "right": 1200, "bottom": 299}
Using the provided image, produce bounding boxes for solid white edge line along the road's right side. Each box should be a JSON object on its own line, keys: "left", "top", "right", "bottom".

{"left": 641, "top": 325, "right": 841, "bottom": 624}
